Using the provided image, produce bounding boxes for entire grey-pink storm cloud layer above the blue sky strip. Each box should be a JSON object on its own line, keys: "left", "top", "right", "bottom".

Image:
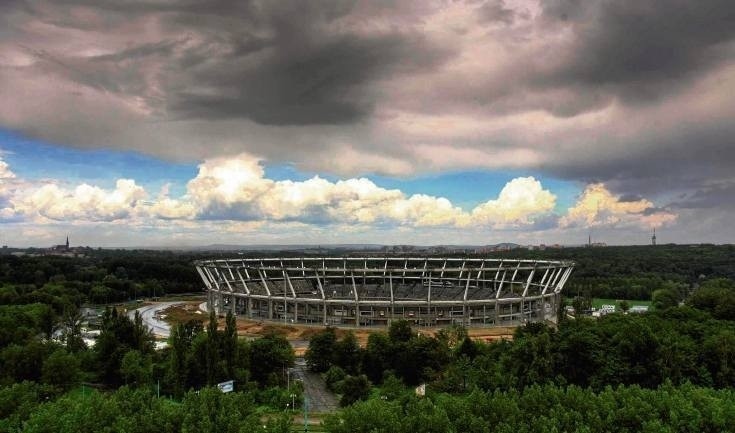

{"left": 0, "top": 0, "right": 735, "bottom": 240}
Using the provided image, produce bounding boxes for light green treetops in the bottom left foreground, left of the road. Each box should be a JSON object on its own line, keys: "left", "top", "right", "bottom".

{"left": 0, "top": 382, "right": 291, "bottom": 433}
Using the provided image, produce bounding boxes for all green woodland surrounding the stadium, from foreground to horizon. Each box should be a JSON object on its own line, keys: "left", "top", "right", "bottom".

{"left": 0, "top": 245, "right": 735, "bottom": 433}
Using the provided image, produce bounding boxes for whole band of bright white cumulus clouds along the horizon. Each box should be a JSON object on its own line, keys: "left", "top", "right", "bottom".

{"left": 0, "top": 150, "right": 676, "bottom": 238}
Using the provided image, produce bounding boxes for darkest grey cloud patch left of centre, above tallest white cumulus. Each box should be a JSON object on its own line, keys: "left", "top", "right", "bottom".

{"left": 169, "top": 34, "right": 443, "bottom": 124}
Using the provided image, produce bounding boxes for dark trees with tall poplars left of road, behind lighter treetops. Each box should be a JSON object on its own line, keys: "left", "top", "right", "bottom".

{"left": 0, "top": 304, "right": 294, "bottom": 394}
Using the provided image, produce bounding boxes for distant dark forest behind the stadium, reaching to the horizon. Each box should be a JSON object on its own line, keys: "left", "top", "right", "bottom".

{"left": 0, "top": 245, "right": 735, "bottom": 310}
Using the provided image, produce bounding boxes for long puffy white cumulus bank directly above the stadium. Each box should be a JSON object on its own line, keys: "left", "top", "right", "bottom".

{"left": 187, "top": 154, "right": 556, "bottom": 227}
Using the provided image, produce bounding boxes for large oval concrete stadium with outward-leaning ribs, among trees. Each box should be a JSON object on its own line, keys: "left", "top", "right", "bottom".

{"left": 195, "top": 257, "right": 574, "bottom": 327}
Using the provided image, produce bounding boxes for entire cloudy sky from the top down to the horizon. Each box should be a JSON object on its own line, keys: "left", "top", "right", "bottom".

{"left": 0, "top": 0, "right": 735, "bottom": 246}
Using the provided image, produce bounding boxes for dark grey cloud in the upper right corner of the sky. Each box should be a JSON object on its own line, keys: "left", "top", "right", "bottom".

{"left": 538, "top": 0, "right": 735, "bottom": 101}
